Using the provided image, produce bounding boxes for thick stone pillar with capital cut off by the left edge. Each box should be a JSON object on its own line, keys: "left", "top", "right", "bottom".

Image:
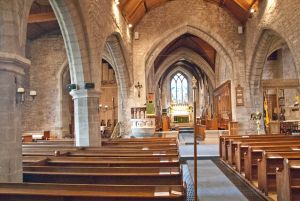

{"left": 0, "top": 52, "right": 30, "bottom": 182}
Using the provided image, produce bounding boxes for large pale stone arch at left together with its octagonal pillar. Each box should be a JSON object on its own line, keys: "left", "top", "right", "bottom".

{"left": 22, "top": 0, "right": 101, "bottom": 146}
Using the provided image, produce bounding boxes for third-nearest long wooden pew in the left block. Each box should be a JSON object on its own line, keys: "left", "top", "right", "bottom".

{"left": 23, "top": 156, "right": 180, "bottom": 167}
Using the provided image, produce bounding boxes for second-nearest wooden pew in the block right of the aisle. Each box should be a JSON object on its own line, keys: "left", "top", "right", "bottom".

{"left": 258, "top": 152, "right": 300, "bottom": 195}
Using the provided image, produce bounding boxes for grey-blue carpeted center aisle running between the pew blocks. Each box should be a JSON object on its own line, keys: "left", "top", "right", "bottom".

{"left": 179, "top": 128, "right": 265, "bottom": 201}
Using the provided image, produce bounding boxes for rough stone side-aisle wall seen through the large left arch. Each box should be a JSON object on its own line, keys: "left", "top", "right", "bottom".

{"left": 22, "top": 35, "right": 66, "bottom": 134}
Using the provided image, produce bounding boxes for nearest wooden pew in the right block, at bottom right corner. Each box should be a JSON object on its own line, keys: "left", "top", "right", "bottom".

{"left": 276, "top": 159, "right": 300, "bottom": 201}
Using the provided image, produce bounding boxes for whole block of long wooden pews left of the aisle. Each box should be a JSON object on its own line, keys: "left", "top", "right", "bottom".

{"left": 0, "top": 138, "right": 186, "bottom": 201}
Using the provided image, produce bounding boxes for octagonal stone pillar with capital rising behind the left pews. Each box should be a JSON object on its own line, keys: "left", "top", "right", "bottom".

{"left": 70, "top": 89, "right": 101, "bottom": 147}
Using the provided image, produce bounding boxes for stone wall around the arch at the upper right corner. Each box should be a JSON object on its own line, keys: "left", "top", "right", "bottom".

{"left": 245, "top": 0, "right": 300, "bottom": 95}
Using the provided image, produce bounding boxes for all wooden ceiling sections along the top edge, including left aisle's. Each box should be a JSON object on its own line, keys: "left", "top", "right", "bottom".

{"left": 27, "top": 0, "right": 261, "bottom": 40}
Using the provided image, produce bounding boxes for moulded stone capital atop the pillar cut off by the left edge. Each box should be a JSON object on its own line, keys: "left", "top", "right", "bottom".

{"left": 0, "top": 52, "right": 31, "bottom": 75}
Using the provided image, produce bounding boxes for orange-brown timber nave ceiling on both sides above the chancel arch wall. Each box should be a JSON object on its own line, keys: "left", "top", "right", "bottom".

{"left": 116, "top": 0, "right": 258, "bottom": 26}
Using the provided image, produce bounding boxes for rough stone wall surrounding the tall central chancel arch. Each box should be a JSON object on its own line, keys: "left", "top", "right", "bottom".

{"left": 129, "top": 0, "right": 248, "bottom": 131}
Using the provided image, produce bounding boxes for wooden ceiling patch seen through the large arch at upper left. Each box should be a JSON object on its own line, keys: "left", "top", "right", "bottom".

{"left": 27, "top": 0, "right": 60, "bottom": 40}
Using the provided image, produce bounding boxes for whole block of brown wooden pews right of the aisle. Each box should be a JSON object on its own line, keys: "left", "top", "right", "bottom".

{"left": 219, "top": 134, "right": 300, "bottom": 201}
